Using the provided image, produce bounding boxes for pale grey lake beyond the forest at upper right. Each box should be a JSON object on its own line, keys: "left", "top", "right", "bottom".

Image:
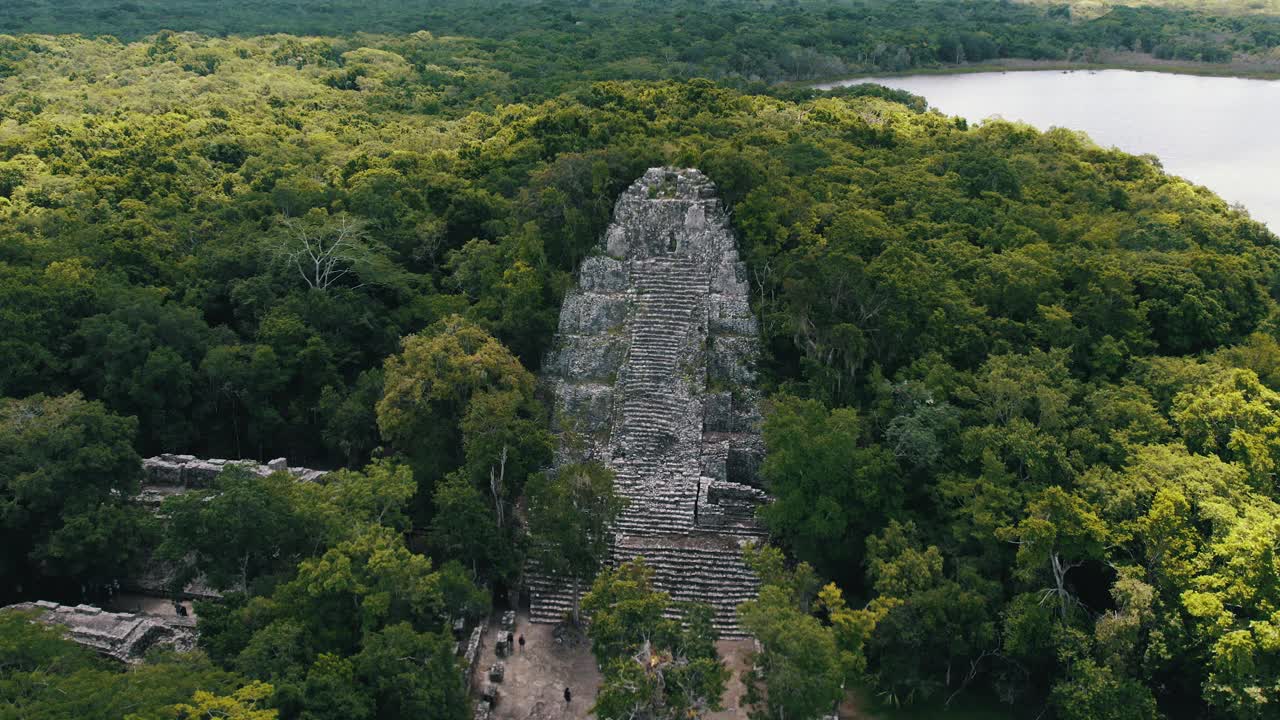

{"left": 818, "top": 70, "right": 1280, "bottom": 232}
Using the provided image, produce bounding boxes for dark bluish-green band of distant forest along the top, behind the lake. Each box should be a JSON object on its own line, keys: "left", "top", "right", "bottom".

{"left": 0, "top": 0, "right": 1280, "bottom": 77}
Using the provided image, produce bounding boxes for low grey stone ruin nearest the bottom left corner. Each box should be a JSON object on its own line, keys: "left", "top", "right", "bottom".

{"left": 3, "top": 600, "right": 196, "bottom": 662}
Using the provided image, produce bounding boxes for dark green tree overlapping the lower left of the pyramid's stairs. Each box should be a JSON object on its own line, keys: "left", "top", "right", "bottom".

{"left": 526, "top": 461, "right": 625, "bottom": 623}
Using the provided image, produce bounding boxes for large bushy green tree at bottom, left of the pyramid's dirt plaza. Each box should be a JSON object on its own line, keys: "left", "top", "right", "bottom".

{"left": 200, "top": 525, "right": 488, "bottom": 720}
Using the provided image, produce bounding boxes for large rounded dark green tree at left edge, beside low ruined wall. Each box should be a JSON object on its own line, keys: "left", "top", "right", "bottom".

{"left": 0, "top": 392, "right": 143, "bottom": 597}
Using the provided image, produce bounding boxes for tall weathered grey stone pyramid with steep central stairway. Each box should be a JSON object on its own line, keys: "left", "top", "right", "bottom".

{"left": 530, "top": 168, "right": 768, "bottom": 635}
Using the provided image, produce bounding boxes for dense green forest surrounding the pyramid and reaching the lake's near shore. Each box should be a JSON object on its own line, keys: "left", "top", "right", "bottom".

{"left": 0, "top": 0, "right": 1280, "bottom": 720}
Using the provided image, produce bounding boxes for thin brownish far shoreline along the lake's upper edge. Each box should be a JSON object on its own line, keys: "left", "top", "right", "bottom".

{"left": 803, "top": 58, "right": 1280, "bottom": 90}
